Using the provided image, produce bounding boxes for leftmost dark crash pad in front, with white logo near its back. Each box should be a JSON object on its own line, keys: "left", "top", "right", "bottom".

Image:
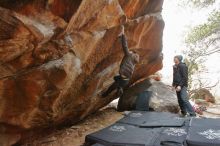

{"left": 85, "top": 123, "right": 162, "bottom": 146}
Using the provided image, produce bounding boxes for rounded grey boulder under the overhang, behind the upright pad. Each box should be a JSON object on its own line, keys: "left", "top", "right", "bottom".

{"left": 118, "top": 79, "right": 179, "bottom": 113}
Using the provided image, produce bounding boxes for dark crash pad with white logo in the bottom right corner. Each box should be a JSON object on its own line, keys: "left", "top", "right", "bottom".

{"left": 186, "top": 118, "right": 220, "bottom": 146}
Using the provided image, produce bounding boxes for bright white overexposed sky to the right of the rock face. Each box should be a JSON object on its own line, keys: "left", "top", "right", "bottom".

{"left": 160, "top": 0, "right": 220, "bottom": 96}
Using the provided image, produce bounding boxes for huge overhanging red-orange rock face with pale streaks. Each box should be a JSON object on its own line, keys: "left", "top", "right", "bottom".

{"left": 0, "top": 0, "right": 164, "bottom": 129}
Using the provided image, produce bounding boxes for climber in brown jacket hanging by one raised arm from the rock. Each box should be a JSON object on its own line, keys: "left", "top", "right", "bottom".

{"left": 102, "top": 25, "right": 139, "bottom": 97}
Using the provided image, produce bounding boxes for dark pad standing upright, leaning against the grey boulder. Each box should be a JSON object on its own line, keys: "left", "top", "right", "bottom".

{"left": 135, "top": 91, "right": 152, "bottom": 111}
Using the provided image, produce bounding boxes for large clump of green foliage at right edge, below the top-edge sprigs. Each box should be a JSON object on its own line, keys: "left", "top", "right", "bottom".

{"left": 186, "top": 11, "right": 220, "bottom": 56}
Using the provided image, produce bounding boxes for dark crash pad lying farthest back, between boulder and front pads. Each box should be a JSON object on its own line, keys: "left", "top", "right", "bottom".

{"left": 118, "top": 111, "right": 185, "bottom": 128}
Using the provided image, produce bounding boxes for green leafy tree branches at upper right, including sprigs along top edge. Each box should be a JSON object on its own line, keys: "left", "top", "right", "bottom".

{"left": 185, "top": 0, "right": 220, "bottom": 56}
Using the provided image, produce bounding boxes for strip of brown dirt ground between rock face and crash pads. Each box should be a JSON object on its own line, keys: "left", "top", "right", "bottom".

{"left": 19, "top": 108, "right": 123, "bottom": 146}
